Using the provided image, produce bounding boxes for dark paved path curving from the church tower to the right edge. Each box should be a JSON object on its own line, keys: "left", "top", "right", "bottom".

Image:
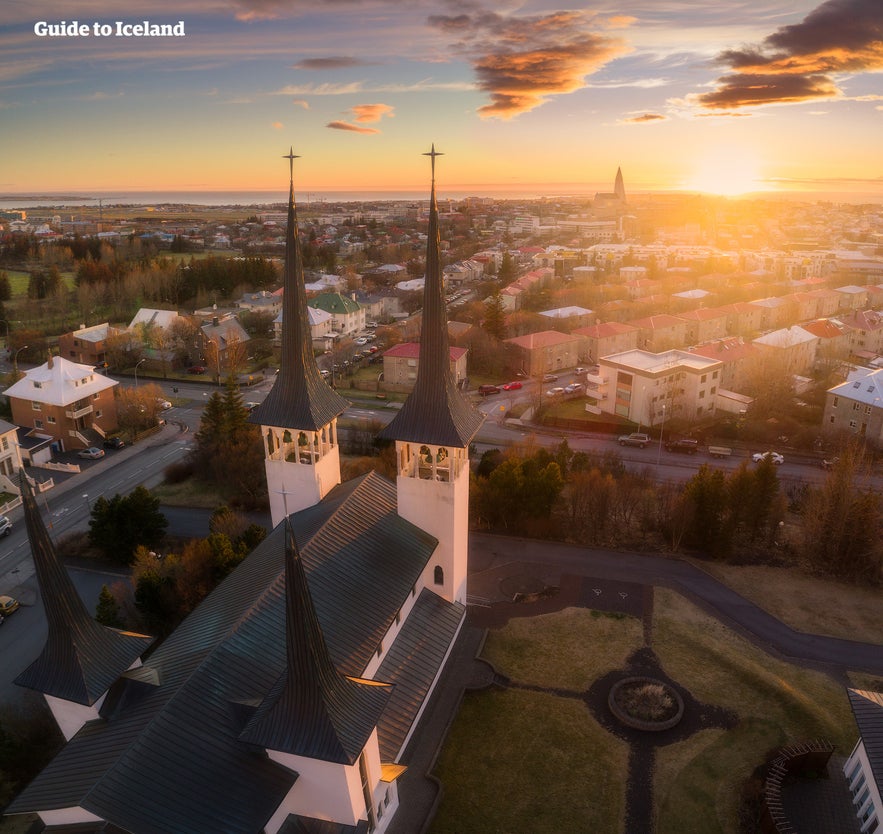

{"left": 469, "top": 533, "right": 883, "bottom": 678}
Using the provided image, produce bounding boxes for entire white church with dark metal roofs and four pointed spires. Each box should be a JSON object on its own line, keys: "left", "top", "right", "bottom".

{"left": 7, "top": 148, "right": 482, "bottom": 834}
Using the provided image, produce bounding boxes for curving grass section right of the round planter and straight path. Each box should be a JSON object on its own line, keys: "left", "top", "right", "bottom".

{"left": 654, "top": 589, "right": 856, "bottom": 834}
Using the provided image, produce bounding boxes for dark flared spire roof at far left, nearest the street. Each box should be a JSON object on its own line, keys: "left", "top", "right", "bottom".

{"left": 15, "top": 470, "right": 153, "bottom": 705}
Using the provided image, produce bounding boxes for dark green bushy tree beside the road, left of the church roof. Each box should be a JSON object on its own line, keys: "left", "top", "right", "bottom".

{"left": 89, "top": 486, "right": 169, "bottom": 565}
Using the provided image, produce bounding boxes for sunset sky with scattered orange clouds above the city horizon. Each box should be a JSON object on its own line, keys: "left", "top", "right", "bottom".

{"left": 0, "top": 0, "right": 883, "bottom": 195}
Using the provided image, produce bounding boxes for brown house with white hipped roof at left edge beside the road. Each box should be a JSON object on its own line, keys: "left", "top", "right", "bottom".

{"left": 4, "top": 356, "right": 119, "bottom": 451}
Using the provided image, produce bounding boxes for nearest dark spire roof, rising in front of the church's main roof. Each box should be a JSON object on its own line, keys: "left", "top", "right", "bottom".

{"left": 239, "top": 517, "right": 392, "bottom": 765}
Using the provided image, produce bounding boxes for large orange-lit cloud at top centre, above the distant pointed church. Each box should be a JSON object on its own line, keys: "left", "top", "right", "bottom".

{"left": 429, "top": 11, "right": 629, "bottom": 119}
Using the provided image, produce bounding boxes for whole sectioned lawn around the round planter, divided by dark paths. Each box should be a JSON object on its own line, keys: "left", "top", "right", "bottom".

{"left": 431, "top": 589, "right": 856, "bottom": 834}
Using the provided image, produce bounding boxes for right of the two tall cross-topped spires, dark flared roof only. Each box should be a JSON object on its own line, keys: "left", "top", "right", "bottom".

{"left": 380, "top": 144, "right": 483, "bottom": 447}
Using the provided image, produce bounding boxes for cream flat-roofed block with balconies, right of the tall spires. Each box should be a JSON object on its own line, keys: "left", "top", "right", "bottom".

{"left": 588, "top": 349, "right": 722, "bottom": 426}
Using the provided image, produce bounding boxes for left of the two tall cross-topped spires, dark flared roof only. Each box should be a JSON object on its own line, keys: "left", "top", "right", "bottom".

{"left": 248, "top": 154, "right": 349, "bottom": 431}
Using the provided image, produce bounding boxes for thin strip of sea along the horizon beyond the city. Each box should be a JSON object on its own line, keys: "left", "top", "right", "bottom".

{"left": 0, "top": 183, "right": 883, "bottom": 210}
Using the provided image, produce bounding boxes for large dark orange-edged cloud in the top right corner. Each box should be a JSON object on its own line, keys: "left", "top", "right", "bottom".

{"left": 693, "top": 0, "right": 883, "bottom": 109}
